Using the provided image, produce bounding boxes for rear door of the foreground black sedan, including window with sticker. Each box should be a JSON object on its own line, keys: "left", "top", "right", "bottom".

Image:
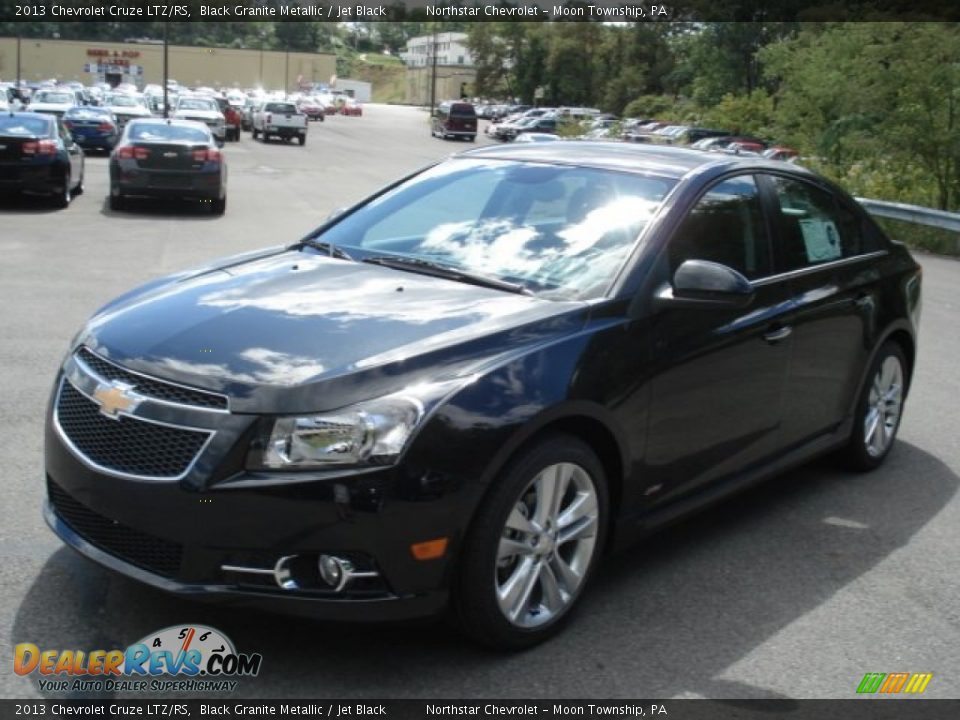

{"left": 761, "top": 174, "right": 882, "bottom": 446}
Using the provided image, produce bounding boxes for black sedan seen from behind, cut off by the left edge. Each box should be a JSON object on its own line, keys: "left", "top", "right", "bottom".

{"left": 0, "top": 112, "right": 84, "bottom": 207}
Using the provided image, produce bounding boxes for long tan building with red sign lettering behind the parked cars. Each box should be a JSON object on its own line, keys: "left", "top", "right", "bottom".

{"left": 0, "top": 37, "right": 336, "bottom": 90}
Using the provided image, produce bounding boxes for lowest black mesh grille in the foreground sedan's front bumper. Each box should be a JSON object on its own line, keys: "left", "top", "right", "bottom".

{"left": 47, "top": 476, "right": 183, "bottom": 577}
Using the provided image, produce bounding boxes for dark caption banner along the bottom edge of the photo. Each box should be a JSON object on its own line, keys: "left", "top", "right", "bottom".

{"left": 0, "top": 699, "right": 960, "bottom": 720}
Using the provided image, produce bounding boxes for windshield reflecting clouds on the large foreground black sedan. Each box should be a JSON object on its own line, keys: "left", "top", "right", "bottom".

{"left": 318, "top": 159, "right": 674, "bottom": 299}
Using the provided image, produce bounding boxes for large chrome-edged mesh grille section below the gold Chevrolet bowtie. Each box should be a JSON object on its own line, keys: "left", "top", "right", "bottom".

{"left": 57, "top": 380, "right": 209, "bottom": 478}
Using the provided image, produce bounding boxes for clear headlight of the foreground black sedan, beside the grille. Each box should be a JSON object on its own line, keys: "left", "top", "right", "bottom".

{"left": 247, "top": 395, "right": 424, "bottom": 470}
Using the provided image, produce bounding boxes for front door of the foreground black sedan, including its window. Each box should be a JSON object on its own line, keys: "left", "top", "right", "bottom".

{"left": 643, "top": 174, "right": 791, "bottom": 504}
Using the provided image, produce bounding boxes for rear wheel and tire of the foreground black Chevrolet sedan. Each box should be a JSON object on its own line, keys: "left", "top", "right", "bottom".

{"left": 841, "top": 341, "right": 908, "bottom": 472}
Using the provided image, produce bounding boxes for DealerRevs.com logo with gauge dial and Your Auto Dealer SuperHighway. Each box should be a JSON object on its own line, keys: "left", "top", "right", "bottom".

{"left": 13, "top": 625, "right": 263, "bottom": 692}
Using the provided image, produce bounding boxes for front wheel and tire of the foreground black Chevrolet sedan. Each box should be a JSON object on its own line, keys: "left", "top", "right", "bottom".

{"left": 453, "top": 435, "right": 609, "bottom": 650}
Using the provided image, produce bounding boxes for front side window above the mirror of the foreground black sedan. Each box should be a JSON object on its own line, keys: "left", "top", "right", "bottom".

{"left": 669, "top": 175, "right": 771, "bottom": 280}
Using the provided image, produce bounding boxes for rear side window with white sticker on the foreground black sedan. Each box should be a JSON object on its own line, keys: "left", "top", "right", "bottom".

{"left": 770, "top": 177, "right": 876, "bottom": 271}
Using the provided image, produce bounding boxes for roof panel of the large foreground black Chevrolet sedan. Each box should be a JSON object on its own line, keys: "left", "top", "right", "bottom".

{"left": 460, "top": 141, "right": 802, "bottom": 179}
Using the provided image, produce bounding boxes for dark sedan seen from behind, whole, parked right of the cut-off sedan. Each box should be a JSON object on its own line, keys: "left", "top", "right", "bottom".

{"left": 110, "top": 118, "right": 227, "bottom": 215}
